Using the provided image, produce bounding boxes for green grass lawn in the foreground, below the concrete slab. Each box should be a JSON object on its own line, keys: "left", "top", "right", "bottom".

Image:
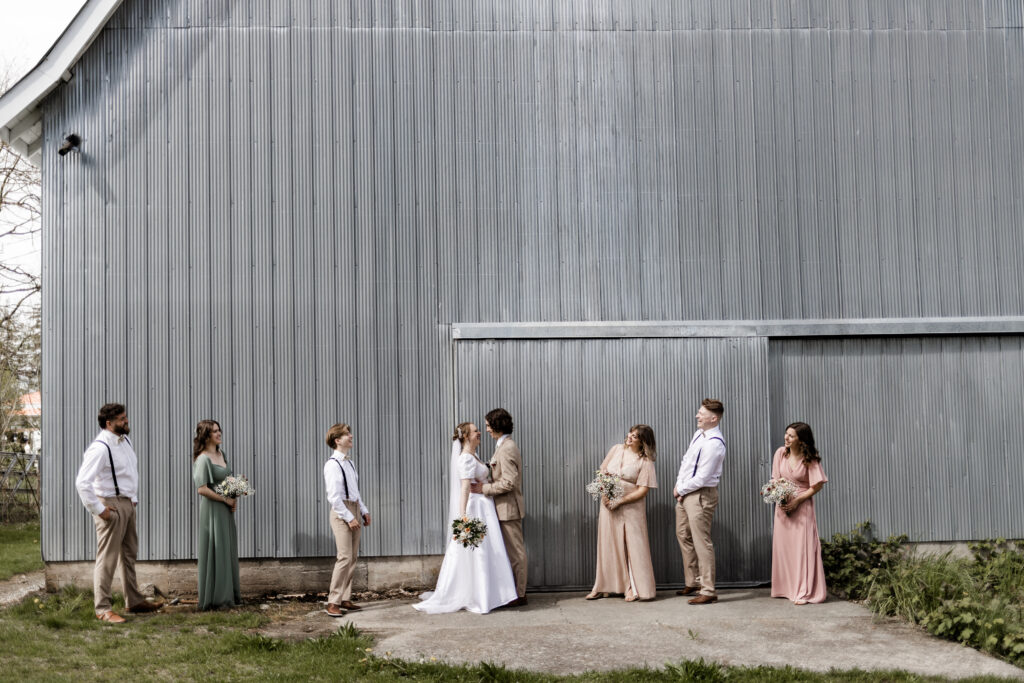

{"left": 0, "top": 588, "right": 1015, "bottom": 682}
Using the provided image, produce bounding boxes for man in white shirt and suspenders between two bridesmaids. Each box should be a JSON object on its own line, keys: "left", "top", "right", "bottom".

{"left": 673, "top": 398, "right": 725, "bottom": 605}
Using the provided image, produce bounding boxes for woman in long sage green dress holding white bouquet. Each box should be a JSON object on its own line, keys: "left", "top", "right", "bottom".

{"left": 193, "top": 420, "right": 242, "bottom": 609}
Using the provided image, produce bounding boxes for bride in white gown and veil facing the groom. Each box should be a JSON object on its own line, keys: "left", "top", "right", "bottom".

{"left": 413, "top": 422, "right": 517, "bottom": 614}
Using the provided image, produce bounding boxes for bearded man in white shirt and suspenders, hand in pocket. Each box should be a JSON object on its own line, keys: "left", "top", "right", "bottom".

{"left": 75, "top": 403, "right": 160, "bottom": 624}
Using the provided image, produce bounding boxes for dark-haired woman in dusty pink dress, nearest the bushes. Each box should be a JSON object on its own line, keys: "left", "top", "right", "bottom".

{"left": 771, "top": 422, "right": 828, "bottom": 605}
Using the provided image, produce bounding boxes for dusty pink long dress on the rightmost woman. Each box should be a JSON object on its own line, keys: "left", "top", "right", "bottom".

{"left": 771, "top": 447, "right": 828, "bottom": 602}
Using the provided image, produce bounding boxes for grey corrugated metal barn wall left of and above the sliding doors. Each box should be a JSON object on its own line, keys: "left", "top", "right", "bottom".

{"left": 37, "top": 0, "right": 1024, "bottom": 577}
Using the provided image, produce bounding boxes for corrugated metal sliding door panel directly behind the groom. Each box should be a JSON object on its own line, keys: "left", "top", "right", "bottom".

{"left": 456, "top": 338, "right": 771, "bottom": 588}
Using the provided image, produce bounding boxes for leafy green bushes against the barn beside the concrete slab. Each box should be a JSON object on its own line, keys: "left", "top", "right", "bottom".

{"left": 822, "top": 522, "right": 1024, "bottom": 666}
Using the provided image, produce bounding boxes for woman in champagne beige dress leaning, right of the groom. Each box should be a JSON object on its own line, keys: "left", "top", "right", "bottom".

{"left": 587, "top": 425, "right": 657, "bottom": 602}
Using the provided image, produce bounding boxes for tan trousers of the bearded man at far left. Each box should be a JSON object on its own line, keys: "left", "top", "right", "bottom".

{"left": 92, "top": 496, "right": 145, "bottom": 614}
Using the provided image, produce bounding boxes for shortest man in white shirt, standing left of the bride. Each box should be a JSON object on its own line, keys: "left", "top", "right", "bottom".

{"left": 324, "top": 423, "right": 370, "bottom": 616}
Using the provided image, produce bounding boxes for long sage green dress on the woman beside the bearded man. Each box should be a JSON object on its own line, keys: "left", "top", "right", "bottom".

{"left": 193, "top": 455, "right": 242, "bottom": 609}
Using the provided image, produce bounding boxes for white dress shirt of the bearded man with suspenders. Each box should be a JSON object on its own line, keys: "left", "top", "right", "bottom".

{"left": 75, "top": 429, "right": 138, "bottom": 515}
